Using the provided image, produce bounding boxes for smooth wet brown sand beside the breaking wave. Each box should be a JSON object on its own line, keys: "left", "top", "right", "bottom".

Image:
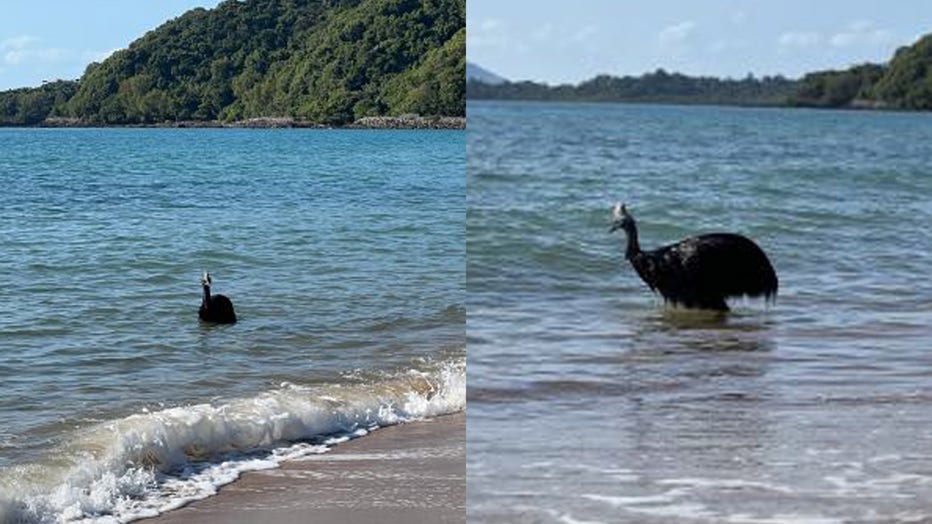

{"left": 139, "top": 413, "right": 466, "bottom": 524}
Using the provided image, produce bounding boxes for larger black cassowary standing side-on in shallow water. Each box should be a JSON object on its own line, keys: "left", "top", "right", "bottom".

{"left": 610, "top": 203, "right": 777, "bottom": 311}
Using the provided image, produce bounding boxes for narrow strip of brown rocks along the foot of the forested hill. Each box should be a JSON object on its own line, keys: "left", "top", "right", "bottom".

{"left": 34, "top": 115, "right": 466, "bottom": 129}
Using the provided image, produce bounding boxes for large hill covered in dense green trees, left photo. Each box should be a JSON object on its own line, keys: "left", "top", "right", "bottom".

{"left": 0, "top": 0, "right": 466, "bottom": 125}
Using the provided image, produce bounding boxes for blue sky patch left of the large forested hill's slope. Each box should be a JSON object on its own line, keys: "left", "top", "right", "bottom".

{"left": 0, "top": 0, "right": 220, "bottom": 90}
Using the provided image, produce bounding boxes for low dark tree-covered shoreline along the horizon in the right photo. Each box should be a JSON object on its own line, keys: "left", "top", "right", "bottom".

{"left": 466, "top": 31, "right": 932, "bottom": 111}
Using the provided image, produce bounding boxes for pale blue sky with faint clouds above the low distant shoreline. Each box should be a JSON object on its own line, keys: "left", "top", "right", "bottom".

{"left": 466, "top": 0, "right": 932, "bottom": 84}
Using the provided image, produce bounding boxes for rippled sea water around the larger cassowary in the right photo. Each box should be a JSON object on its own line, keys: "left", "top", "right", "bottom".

{"left": 466, "top": 103, "right": 932, "bottom": 523}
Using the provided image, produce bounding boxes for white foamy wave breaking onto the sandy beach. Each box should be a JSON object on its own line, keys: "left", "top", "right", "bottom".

{"left": 0, "top": 359, "right": 466, "bottom": 523}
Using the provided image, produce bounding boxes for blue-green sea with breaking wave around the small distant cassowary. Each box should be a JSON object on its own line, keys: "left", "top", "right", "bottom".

{"left": 0, "top": 129, "right": 466, "bottom": 522}
